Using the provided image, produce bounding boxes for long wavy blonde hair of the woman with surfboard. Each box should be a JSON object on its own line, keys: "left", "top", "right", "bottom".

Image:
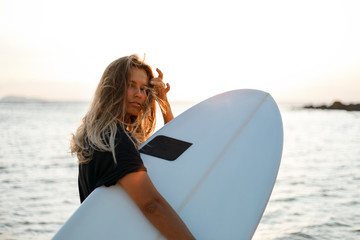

{"left": 70, "top": 55, "right": 162, "bottom": 163}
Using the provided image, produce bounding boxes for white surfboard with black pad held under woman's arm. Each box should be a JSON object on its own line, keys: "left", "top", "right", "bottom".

{"left": 53, "top": 90, "right": 283, "bottom": 240}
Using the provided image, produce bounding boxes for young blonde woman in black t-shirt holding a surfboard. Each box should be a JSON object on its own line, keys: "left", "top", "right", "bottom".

{"left": 71, "top": 55, "right": 194, "bottom": 239}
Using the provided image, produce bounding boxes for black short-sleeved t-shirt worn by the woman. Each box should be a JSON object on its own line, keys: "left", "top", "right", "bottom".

{"left": 78, "top": 126, "right": 146, "bottom": 202}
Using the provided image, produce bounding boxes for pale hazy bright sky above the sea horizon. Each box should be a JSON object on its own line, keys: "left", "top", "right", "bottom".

{"left": 0, "top": 0, "right": 360, "bottom": 103}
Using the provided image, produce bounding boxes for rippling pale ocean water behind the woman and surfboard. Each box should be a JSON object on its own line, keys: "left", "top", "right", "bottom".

{"left": 0, "top": 102, "right": 360, "bottom": 240}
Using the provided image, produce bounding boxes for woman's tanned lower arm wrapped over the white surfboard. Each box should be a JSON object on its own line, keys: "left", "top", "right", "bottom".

{"left": 118, "top": 171, "right": 195, "bottom": 239}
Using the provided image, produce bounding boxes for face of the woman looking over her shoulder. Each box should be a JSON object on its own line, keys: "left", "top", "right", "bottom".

{"left": 126, "top": 67, "right": 148, "bottom": 117}
